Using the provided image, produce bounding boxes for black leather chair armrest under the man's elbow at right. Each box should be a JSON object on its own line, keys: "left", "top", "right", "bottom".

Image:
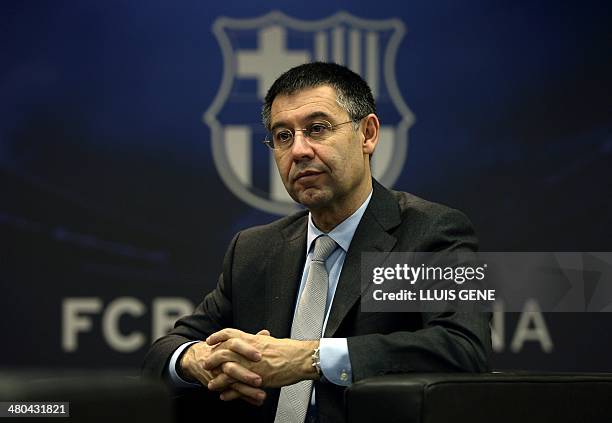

{"left": 345, "top": 372, "right": 612, "bottom": 423}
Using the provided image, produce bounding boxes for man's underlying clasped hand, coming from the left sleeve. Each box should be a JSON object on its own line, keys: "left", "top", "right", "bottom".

{"left": 179, "top": 331, "right": 269, "bottom": 406}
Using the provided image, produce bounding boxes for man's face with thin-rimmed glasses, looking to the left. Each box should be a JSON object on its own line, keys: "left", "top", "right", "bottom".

{"left": 270, "top": 86, "right": 370, "bottom": 210}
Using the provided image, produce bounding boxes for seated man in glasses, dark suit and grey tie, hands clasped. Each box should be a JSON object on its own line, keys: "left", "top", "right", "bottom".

{"left": 144, "top": 63, "right": 491, "bottom": 422}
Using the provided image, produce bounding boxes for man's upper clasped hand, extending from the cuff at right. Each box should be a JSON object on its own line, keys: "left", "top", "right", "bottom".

{"left": 204, "top": 328, "right": 319, "bottom": 391}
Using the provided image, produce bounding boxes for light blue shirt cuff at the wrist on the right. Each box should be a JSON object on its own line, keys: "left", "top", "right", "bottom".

{"left": 319, "top": 338, "right": 353, "bottom": 386}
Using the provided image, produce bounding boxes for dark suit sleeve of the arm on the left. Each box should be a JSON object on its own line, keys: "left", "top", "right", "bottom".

{"left": 142, "top": 233, "right": 240, "bottom": 378}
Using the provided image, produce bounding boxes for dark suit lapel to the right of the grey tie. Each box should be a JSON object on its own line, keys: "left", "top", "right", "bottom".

{"left": 324, "top": 180, "right": 401, "bottom": 337}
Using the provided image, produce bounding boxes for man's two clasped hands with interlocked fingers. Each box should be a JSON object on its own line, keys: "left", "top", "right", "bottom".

{"left": 180, "top": 328, "right": 319, "bottom": 406}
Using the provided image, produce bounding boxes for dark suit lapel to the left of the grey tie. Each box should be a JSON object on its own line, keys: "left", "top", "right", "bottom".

{"left": 265, "top": 215, "right": 308, "bottom": 338}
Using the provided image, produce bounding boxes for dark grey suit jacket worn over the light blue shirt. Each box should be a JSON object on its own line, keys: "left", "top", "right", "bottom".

{"left": 143, "top": 181, "right": 491, "bottom": 422}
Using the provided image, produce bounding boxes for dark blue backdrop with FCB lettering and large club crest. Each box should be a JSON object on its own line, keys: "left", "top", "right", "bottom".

{"left": 0, "top": 0, "right": 612, "bottom": 374}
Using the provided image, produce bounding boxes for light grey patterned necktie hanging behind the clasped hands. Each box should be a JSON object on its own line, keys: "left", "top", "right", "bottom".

{"left": 274, "top": 235, "right": 337, "bottom": 423}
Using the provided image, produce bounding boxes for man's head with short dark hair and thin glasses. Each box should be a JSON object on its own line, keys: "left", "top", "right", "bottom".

{"left": 262, "top": 63, "right": 379, "bottom": 226}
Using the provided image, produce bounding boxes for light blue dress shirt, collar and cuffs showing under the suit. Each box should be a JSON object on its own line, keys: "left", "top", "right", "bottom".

{"left": 168, "top": 192, "right": 372, "bottom": 390}
